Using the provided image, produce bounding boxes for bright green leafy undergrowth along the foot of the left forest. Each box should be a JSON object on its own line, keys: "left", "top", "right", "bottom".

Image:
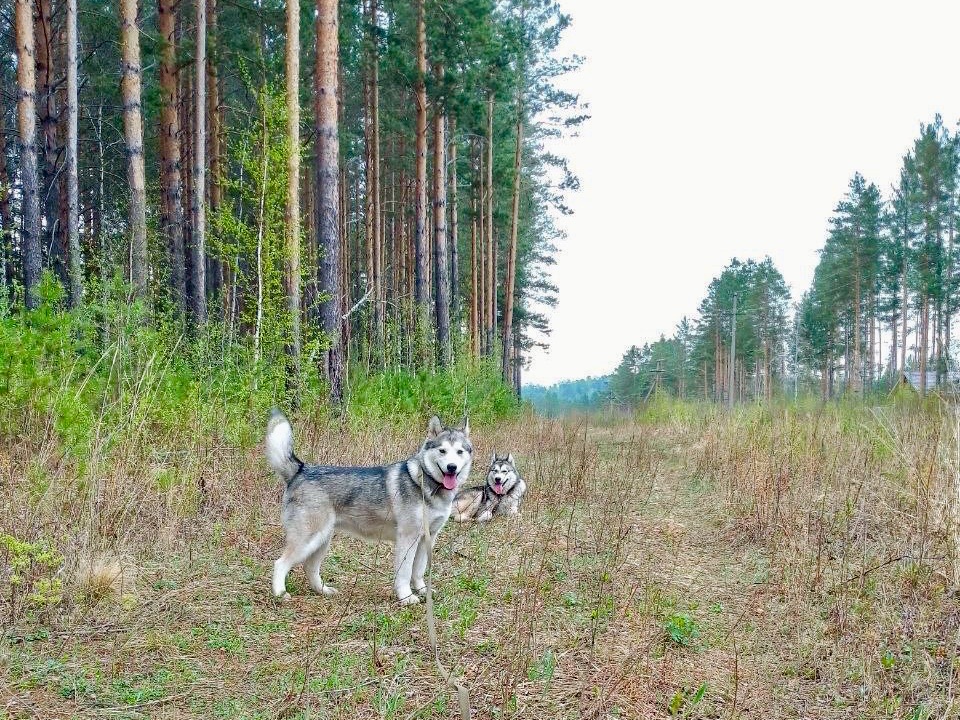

{"left": 0, "top": 278, "right": 520, "bottom": 461}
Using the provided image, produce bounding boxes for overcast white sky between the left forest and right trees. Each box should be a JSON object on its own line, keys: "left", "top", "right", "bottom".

{"left": 524, "top": 0, "right": 960, "bottom": 383}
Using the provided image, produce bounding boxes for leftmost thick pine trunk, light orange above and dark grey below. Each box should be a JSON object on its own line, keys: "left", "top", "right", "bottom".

{"left": 14, "top": 0, "right": 40, "bottom": 309}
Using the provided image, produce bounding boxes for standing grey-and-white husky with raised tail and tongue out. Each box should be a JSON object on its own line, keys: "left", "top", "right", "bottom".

{"left": 265, "top": 410, "right": 473, "bottom": 605}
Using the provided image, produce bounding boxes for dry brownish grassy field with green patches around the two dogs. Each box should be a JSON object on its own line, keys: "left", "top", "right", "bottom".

{"left": 0, "top": 405, "right": 960, "bottom": 720}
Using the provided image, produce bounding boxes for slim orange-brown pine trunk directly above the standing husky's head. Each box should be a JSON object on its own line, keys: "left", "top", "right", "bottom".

{"left": 433, "top": 64, "right": 450, "bottom": 368}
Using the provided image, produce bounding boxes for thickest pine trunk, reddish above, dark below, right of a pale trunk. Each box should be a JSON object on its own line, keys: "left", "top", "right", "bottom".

{"left": 316, "top": 0, "right": 343, "bottom": 406}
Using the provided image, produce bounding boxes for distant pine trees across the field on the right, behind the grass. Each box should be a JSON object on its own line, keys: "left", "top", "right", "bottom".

{"left": 530, "top": 116, "right": 960, "bottom": 411}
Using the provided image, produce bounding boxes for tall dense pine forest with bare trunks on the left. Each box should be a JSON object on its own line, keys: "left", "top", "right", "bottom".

{"left": 0, "top": 0, "right": 585, "bottom": 404}
